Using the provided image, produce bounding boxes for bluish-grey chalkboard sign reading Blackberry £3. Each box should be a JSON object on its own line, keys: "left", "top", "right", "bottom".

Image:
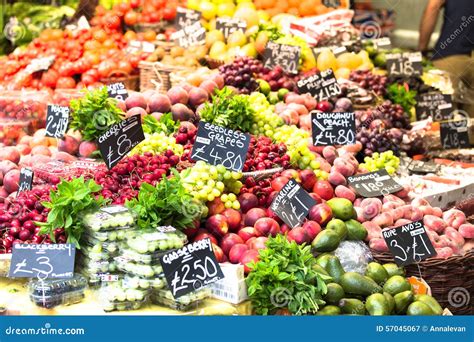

{"left": 8, "top": 243, "right": 76, "bottom": 279}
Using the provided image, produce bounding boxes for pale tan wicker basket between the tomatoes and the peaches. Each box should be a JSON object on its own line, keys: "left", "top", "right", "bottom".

{"left": 138, "top": 62, "right": 191, "bottom": 93}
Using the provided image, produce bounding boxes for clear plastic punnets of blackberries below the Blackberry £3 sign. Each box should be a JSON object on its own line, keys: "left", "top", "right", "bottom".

{"left": 28, "top": 274, "right": 87, "bottom": 309}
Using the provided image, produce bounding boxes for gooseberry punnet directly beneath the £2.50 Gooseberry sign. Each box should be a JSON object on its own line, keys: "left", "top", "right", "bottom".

{"left": 150, "top": 288, "right": 211, "bottom": 311}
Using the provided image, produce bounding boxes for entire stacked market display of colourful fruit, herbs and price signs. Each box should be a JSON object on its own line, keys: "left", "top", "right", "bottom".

{"left": 0, "top": 0, "right": 474, "bottom": 315}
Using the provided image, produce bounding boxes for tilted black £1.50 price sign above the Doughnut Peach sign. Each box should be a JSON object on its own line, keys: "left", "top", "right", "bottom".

{"left": 296, "top": 69, "right": 341, "bottom": 102}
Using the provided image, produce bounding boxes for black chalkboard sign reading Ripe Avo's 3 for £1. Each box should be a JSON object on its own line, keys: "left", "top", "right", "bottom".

{"left": 382, "top": 221, "right": 437, "bottom": 266}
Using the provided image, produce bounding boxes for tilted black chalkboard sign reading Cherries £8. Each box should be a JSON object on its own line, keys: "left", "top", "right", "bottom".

{"left": 98, "top": 115, "right": 145, "bottom": 169}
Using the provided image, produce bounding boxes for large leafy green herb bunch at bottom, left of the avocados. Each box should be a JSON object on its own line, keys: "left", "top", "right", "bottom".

{"left": 246, "top": 235, "right": 330, "bottom": 315}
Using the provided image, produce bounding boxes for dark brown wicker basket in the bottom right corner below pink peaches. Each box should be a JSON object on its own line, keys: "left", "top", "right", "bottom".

{"left": 372, "top": 250, "right": 474, "bottom": 315}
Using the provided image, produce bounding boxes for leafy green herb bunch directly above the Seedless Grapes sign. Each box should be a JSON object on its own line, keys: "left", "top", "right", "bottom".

{"left": 200, "top": 87, "right": 255, "bottom": 132}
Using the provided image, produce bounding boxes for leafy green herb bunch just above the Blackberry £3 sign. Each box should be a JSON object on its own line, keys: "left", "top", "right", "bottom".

{"left": 35, "top": 176, "right": 106, "bottom": 248}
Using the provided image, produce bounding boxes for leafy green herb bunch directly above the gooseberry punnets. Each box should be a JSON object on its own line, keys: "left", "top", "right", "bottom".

{"left": 125, "top": 170, "right": 203, "bottom": 229}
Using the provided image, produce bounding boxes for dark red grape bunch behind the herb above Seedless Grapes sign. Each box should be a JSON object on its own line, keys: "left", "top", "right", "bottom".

{"left": 219, "top": 57, "right": 263, "bottom": 94}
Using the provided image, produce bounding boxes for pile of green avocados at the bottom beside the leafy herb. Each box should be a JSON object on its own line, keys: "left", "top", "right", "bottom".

{"left": 313, "top": 253, "right": 443, "bottom": 316}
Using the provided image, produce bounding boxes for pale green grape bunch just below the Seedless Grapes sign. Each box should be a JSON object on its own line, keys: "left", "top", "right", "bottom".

{"left": 181, "top": 160, "right": 242, "bottom": 207}
